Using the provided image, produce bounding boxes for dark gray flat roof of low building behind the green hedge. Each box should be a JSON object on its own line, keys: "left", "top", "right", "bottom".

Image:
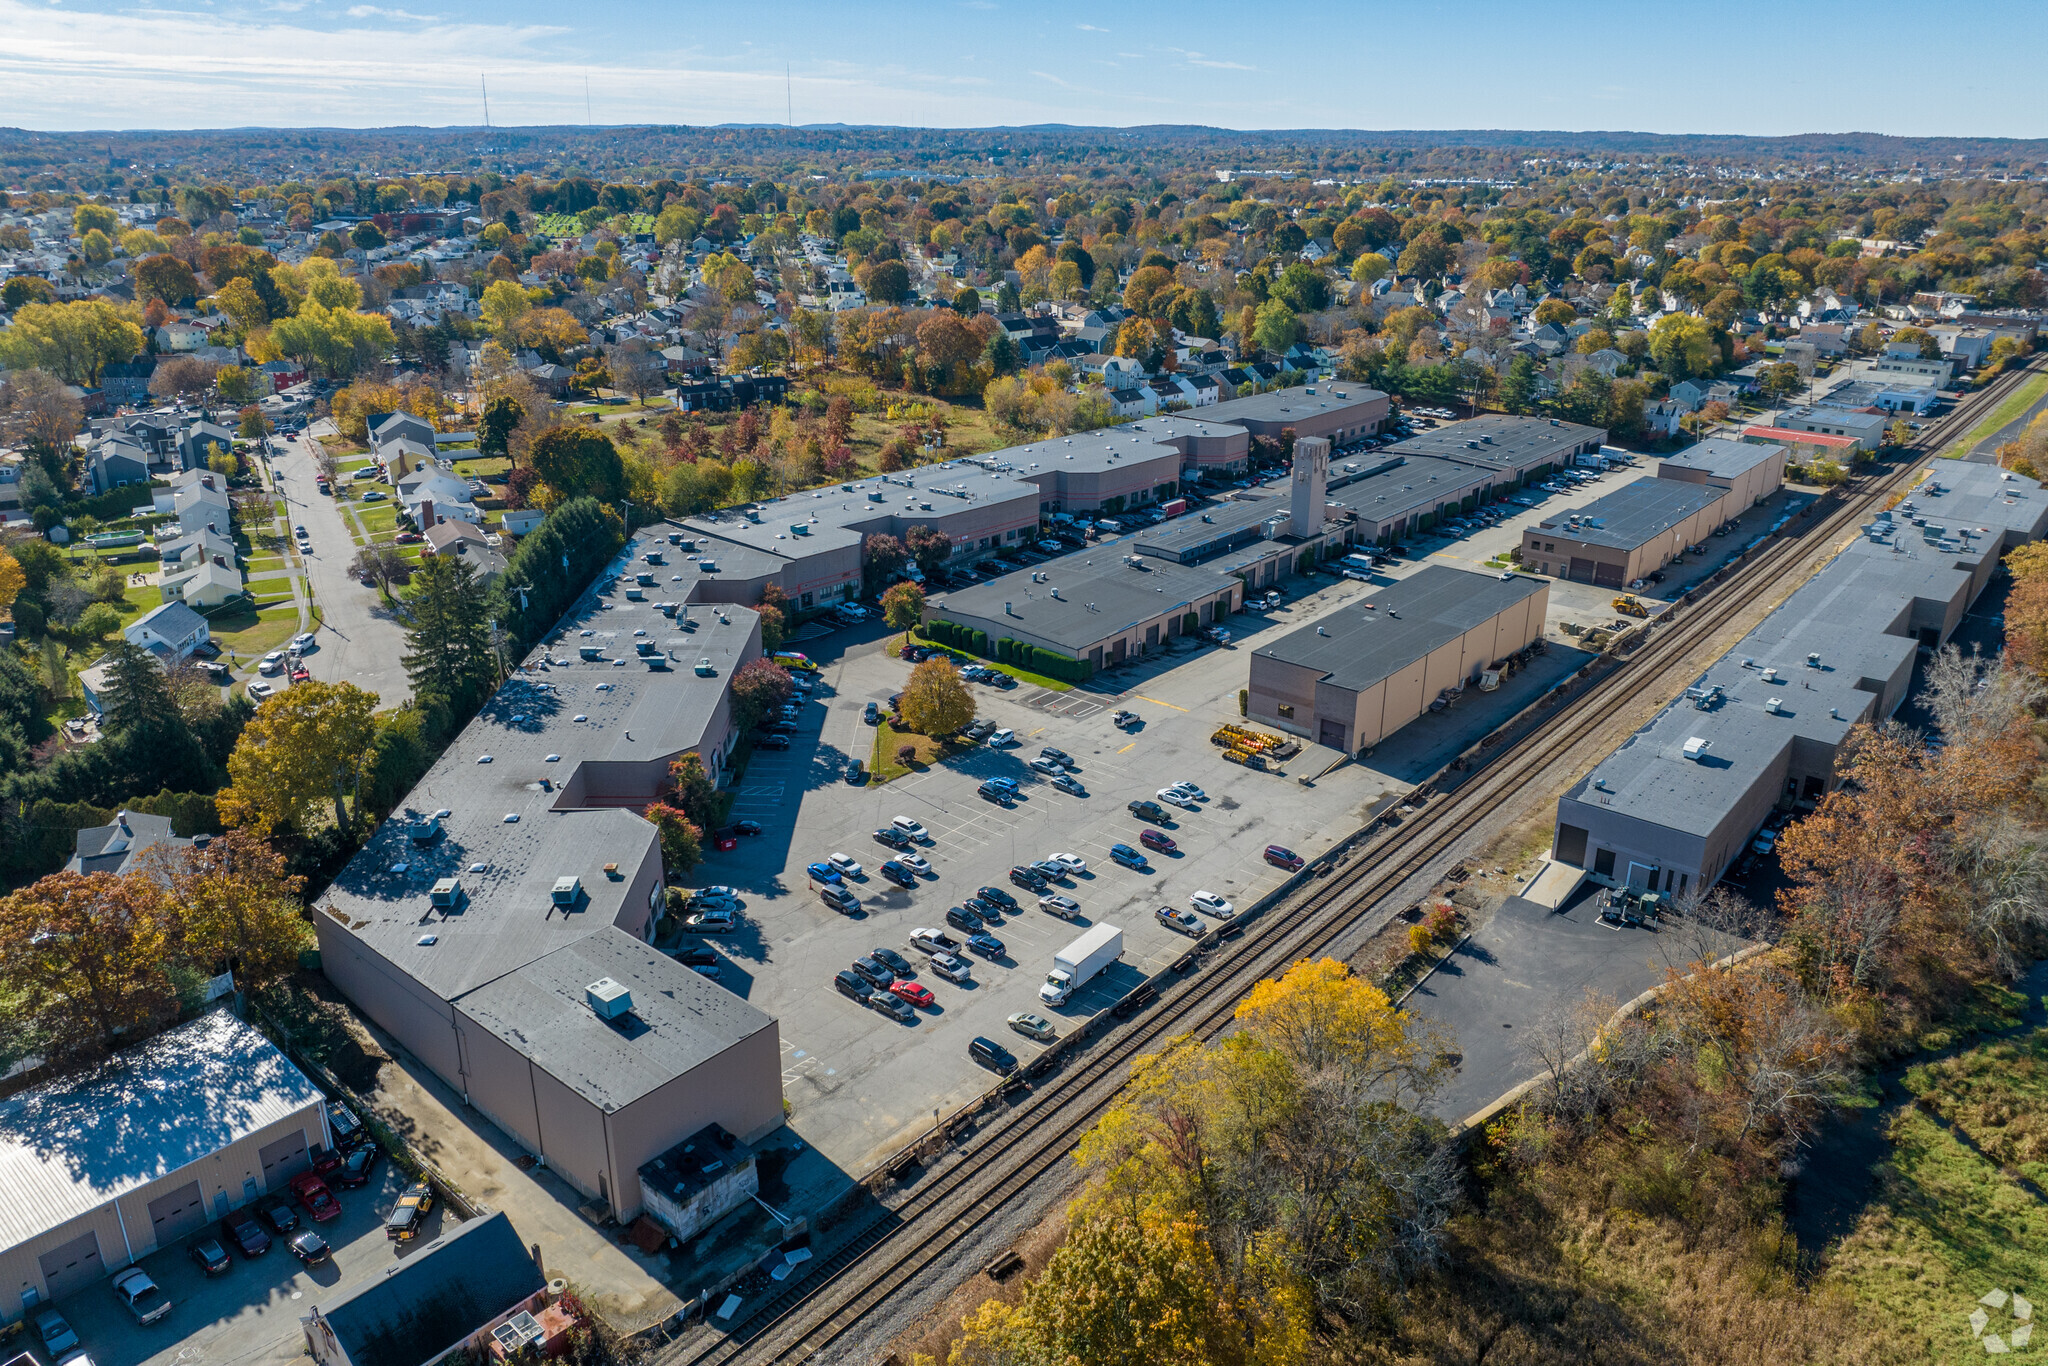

{"left": 926, "top": 545, "right": 1237, "bottom": 657}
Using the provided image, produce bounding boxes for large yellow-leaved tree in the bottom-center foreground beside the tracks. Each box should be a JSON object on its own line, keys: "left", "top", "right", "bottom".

{"left": 952, "top": 958, "right": 1456, "bottom": 1366}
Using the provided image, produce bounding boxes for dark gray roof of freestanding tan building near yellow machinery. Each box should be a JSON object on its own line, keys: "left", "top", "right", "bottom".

{"left": 1255, "top": 565, "right": 1544, "bottom": 692}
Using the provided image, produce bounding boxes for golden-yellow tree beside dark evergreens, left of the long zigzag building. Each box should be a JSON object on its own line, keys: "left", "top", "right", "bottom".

{"left": 215, "top": 680, "right": 377, "bottom": 840}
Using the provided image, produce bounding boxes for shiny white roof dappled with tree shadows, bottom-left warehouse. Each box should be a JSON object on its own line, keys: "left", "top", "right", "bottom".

{"left": 0, "top": 1010, "right": 326, "bottom": 1249}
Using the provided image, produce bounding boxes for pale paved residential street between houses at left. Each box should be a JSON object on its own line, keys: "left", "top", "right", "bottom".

{"left": 270, "top": 436, "right": 412, "bottom": 707}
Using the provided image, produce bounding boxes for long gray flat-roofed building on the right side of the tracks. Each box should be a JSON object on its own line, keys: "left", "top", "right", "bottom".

{"left": 1552, "top": 461, "right": 2048, "bottom": 893}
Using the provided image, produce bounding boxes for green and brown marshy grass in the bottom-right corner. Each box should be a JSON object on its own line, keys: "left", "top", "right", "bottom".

{"left": 1825, "top": 1003, "right": 2048, "bottom": 1362}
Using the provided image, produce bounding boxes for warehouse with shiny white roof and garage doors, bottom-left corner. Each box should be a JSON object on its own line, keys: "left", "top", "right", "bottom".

{"left": 0, "top": 1010, "right": 334, "bottom": 1321}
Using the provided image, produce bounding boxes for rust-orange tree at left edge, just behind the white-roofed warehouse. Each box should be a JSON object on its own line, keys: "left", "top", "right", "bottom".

{"left": 0, "top": 872, "right": 178, "bottom": 1059}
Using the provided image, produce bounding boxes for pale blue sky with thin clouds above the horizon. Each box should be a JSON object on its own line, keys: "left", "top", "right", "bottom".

{"left": 0, "top": 0, "right": 2048, "bottom": 137}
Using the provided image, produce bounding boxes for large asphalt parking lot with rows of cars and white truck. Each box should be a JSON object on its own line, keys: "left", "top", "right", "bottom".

{"left": 686, "top": 578, "right": 1577, "bottom": 1173}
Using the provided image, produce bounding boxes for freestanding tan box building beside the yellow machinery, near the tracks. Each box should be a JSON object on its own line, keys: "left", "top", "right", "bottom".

{"left": 1247, "top": 565, "right": 1550, "bottom": 752}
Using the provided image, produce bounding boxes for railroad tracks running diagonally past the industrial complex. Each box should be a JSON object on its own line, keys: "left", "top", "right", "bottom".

{"left": 657, "top": 356, "right": 2034, "bottom": 1366}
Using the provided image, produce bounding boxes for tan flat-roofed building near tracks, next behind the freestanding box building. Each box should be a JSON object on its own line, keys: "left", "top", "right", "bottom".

{"left": 1522, "top": 479, "right": 1747, "bottom": 588}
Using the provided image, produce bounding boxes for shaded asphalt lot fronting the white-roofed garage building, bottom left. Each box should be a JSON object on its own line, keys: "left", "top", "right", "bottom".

{"left": 57, "top": 1161, "right": 444, "bottom": 1366}
